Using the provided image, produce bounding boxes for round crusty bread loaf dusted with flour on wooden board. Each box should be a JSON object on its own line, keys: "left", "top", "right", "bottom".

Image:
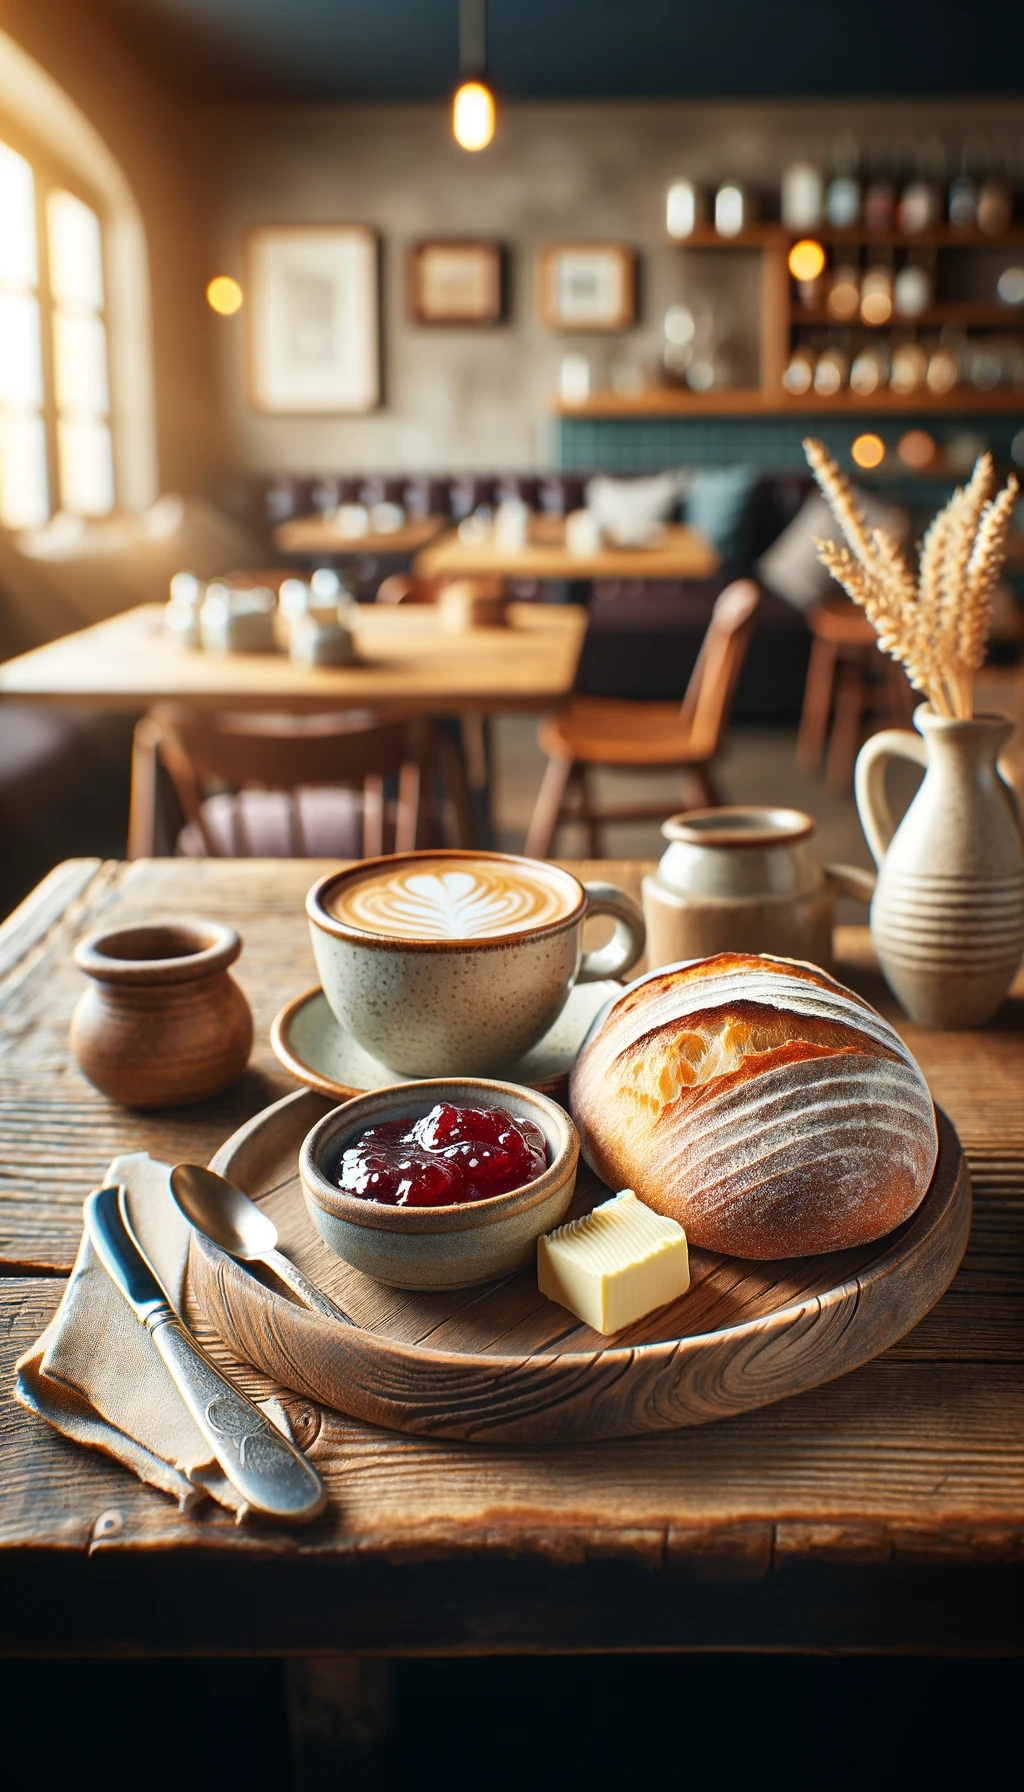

{"left": 570, "top": 952, "right": 938, "bottom": 1258}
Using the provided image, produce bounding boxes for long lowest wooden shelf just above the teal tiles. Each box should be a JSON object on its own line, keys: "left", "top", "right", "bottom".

{"left": 554, "top": 387, "right": 1024, "bottom": 418}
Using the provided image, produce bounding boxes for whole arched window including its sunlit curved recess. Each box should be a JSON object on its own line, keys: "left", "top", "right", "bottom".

{"left": 0, "top": 32, "right": 156, "bottom": 529}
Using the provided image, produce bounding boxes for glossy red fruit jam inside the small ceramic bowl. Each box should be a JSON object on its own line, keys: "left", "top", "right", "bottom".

{"left": 337, "top": 1102, "right": 547, "bottom": 1208}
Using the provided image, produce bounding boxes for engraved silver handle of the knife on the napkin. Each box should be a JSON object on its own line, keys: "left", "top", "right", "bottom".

{"left": 145, "top": 1306, "right": 326, "bottom": 1521}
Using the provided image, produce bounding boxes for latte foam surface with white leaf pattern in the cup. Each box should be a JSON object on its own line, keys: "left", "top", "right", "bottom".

{"left": 328, "top": 858, "right": 576, "bottom": 939}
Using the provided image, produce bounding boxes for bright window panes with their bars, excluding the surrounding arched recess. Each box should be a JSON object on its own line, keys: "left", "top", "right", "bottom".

{"left": 0, "top": 142, "right": 115, "bottom": 529}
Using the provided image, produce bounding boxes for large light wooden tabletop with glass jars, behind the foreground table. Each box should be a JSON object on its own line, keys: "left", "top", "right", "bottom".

{"left": 0, "top": 604, "right": 586, "bottom": 715}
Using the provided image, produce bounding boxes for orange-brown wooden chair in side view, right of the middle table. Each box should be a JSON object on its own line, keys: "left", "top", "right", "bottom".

{"left": 525, "top": 579, "right": 760, "bottom": 858}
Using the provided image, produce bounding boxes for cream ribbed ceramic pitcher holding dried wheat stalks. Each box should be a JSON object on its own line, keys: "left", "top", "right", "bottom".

{"left": 857, "top": 702, "right": 1024, "bottom": 1027}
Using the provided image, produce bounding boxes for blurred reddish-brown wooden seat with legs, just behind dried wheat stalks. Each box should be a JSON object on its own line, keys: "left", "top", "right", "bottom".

{"left": 796, "top": 597, "right": 916, "bottom": 796}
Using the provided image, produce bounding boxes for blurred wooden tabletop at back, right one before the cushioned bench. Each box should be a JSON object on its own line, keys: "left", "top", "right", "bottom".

{"left": 412, "top": 516, "right": 719, "bottom": 579}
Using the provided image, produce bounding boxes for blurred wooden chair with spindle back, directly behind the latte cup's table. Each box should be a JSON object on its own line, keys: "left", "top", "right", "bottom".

{"left": 129, "top": 710, "right": 470, "bottom": 858}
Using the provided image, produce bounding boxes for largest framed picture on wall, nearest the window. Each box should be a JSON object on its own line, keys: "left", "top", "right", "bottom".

{"left": 246, "top": 224, "right": 380, "bottom": 416}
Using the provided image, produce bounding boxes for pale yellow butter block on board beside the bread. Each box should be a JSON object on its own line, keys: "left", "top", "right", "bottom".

{"left": 536, "top": 1188, "right": 690, "bottom": 1331}
